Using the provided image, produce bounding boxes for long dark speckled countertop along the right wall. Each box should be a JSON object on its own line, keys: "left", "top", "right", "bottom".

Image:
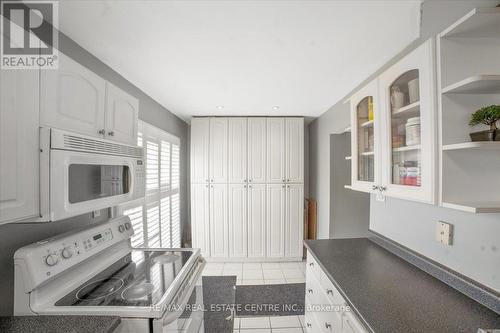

{"left": 304, "top": 238, "right": 500, "bottom": 333}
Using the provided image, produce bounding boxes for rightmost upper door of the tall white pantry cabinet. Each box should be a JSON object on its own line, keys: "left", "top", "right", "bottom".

{"left": 285, "top": 118, "right": 304, "bottom": 183}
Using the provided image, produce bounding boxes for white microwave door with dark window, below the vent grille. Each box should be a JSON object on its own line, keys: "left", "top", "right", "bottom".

{"left": 49, "top": 149, "right": 142, "bottom": 221}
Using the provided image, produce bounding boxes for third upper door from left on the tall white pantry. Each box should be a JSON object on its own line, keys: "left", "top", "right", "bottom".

{"left": 228, "top": 118, "right": 247, "bottom": 183}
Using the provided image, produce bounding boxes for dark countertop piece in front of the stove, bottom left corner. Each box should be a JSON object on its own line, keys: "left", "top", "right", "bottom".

{"left": 0, "top": 316, "right": 121, "bottom": 333}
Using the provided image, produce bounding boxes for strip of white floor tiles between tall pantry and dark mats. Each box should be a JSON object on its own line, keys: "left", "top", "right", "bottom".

{"left": 203, "top": 261, "right": 306, "bottom": 285}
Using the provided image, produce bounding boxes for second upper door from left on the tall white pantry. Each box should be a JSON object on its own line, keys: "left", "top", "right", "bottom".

{"left": 209, "top": 118, "right": 228, "bottom": 183}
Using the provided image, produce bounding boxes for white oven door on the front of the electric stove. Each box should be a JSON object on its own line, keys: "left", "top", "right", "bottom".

{"left": 153, "top": 257, "right": 205, "bottom": 333}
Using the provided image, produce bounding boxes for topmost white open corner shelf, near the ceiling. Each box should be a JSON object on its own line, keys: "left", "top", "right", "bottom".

{"left": 441, "top": 7, "right": 500, "bottom": 38}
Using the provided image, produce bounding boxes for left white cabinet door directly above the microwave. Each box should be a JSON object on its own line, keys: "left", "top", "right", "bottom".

{"left": 40, "top": 52, "right": 106, "bottom": 138}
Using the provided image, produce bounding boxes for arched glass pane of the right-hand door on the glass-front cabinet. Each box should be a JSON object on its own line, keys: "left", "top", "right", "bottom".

{"left": 389, "top": 69, "right": 422, "bottom": 187}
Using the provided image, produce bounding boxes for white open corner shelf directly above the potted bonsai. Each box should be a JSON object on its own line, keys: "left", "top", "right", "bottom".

{"left": 442, "top": 75, "right": 500, "bottom": 94}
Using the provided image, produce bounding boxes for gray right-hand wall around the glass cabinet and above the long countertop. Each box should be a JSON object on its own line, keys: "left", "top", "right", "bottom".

{"left": 309, "top": 0, "right": 500, "bottom": 291}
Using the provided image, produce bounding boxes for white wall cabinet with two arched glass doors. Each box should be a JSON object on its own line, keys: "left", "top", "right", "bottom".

{"left": 350, "top": 39, "right": 437, "bottom": 203}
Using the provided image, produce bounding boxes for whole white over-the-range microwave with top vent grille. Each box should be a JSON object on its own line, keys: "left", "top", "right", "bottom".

{"left": 40, "top": 128, "right": 145, "bottom": 221}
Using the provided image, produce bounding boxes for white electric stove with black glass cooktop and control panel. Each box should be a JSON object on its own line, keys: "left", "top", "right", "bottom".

{"left": 14, "top": 216, "right": 205, "bottom": 333}
